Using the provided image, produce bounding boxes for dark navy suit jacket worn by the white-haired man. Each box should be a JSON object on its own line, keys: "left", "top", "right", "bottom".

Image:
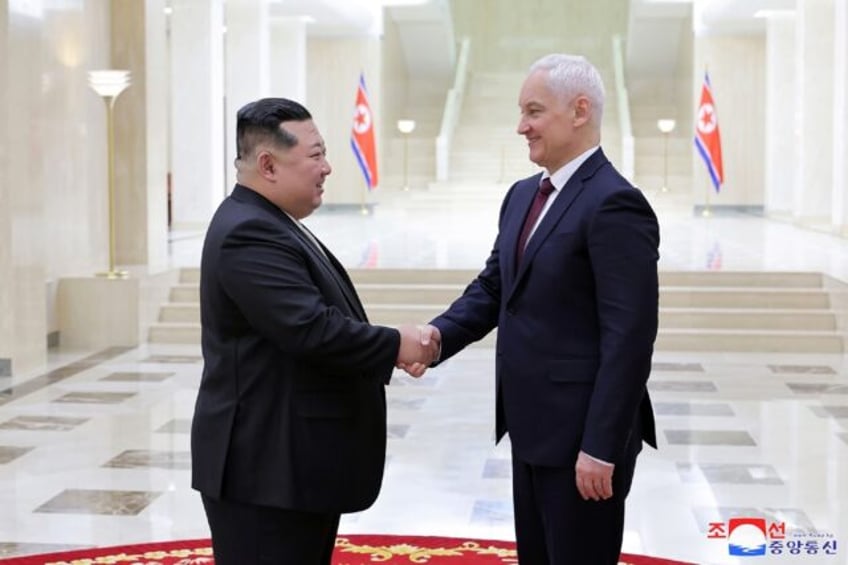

{"left": 432, "top": 149, "right": 659, "bottom": 466}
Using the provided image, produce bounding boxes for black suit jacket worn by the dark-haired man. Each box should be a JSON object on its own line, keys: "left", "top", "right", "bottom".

{"left": 191, "top": 185, "right": 400, "bottom": 512}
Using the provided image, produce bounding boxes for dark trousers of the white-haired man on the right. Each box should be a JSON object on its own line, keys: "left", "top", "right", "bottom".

{"left": 512, "top": 441, "right": 641, "bottom": 565}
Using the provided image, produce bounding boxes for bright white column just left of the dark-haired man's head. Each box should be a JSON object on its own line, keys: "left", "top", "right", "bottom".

{"left": 169, "top": 0, "right": 222, "bottom": 229}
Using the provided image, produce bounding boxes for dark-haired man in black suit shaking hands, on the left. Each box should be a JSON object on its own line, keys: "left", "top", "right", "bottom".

{"left": 191, "top": 98, "right": 436, "bottom": 565}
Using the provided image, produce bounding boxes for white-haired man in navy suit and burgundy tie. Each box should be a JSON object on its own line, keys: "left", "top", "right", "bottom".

{"left": 407, "top": 55, "right": 659, "bottom": 565}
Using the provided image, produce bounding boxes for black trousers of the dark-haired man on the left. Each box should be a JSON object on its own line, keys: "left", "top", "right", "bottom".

{"left": 202, "top": 495, "right": 340, "bottom": 565}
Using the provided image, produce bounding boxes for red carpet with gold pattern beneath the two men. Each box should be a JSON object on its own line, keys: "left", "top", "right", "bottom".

{"left": 0, "top": 535, "right": 692, "bottom": 565}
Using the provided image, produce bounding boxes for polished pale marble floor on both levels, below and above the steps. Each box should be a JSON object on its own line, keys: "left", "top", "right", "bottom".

{"left": 0, "top": 183, "right": 848, "bottom": 565}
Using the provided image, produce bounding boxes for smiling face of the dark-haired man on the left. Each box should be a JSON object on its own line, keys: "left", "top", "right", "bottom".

{"left": 259, "top": 120, "right": 332, "bottom": 220}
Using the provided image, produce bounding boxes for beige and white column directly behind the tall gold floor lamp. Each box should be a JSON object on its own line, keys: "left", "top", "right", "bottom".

{"left": 110, "top": 0, "right": 168, "bottom": 273}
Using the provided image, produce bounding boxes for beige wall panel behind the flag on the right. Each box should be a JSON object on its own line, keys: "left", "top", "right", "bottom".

{"left": 689, "top": 36, "right": 766, "bottom": 206}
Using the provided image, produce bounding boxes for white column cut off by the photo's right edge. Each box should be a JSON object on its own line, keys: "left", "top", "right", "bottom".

{"left": 831, "top": 2, "right": 848, "bottom": 236}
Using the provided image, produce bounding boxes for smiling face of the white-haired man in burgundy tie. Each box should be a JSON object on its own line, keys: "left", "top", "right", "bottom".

{"left": 517, "top": 69, "right": 593, "bottom": 173}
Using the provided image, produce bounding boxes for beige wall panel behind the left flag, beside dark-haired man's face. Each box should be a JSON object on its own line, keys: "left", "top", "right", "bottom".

{"left": 306, "top": 37, "right": 382, "bottom": 205}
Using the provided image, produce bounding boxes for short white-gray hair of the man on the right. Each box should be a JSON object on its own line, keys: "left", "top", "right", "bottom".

{"left": 530, "top": 53, "right": 605, "bottom": 126}
